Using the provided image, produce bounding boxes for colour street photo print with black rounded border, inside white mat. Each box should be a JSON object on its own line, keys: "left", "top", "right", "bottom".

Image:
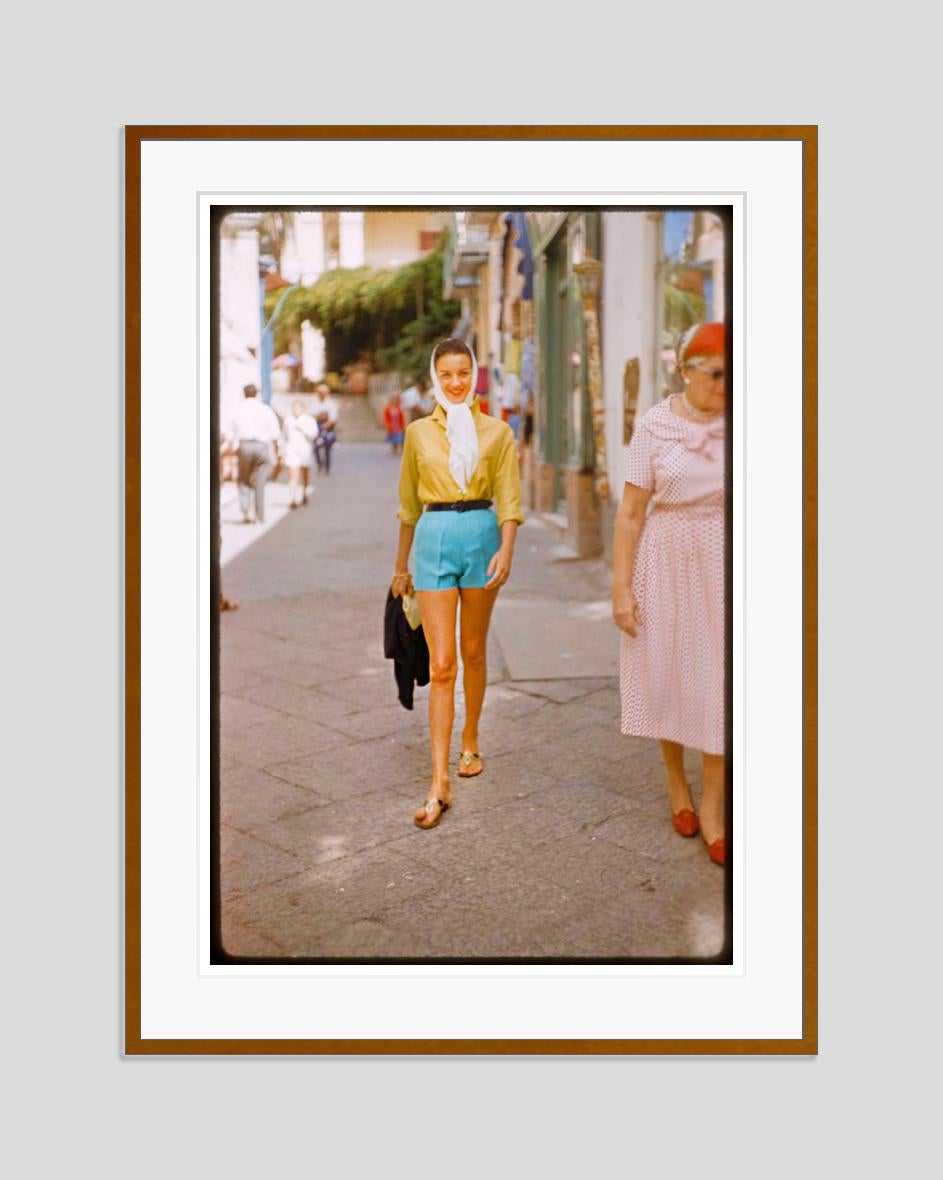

{"left": 214, "top": 207, "right": 733, "bottom": 963}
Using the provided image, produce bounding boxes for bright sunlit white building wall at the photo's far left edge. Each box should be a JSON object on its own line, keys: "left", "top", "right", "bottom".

{"left": 220, "top": 224, "right": 262, "bottom": 430}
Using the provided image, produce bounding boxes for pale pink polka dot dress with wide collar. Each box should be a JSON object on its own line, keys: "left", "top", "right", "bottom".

{"left": 620, "top": 398, "right": 725, "bottom": 754}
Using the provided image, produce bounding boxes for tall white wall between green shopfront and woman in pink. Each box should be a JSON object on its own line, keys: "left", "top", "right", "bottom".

{"left": 601, "top": 212, "right": 661, "bottom": 503}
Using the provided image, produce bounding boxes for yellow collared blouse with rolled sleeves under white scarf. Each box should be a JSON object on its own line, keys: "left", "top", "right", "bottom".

{"left": 397, "top": 398, "right": 524, "bottom": 525}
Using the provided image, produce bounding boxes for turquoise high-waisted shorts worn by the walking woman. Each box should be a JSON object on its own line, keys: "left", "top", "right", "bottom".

{"left": 413, "top": 509, "right": 500, "bottom": 590}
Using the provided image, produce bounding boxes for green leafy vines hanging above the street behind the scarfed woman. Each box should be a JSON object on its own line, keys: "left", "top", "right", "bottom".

{"left": 266, "top": 241, "right": 461, "bottom": 380}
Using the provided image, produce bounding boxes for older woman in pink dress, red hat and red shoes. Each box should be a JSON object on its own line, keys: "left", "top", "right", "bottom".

{"left": 613, "top": 323, "right": 726, "bottom": 865}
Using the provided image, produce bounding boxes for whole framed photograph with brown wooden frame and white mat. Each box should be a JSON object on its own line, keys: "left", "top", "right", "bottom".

{"left": 125, "top": 126, "right": 817, "bottom": 1054}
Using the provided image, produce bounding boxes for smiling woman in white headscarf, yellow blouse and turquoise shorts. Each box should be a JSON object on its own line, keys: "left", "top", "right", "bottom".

{"left": 391, "top": 337, "right": 524, "bottom": 828}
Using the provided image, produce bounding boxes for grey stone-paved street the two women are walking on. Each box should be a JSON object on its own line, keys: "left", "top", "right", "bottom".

{"left": 220, "top": 424, "right": 725, "bottom": 962}
